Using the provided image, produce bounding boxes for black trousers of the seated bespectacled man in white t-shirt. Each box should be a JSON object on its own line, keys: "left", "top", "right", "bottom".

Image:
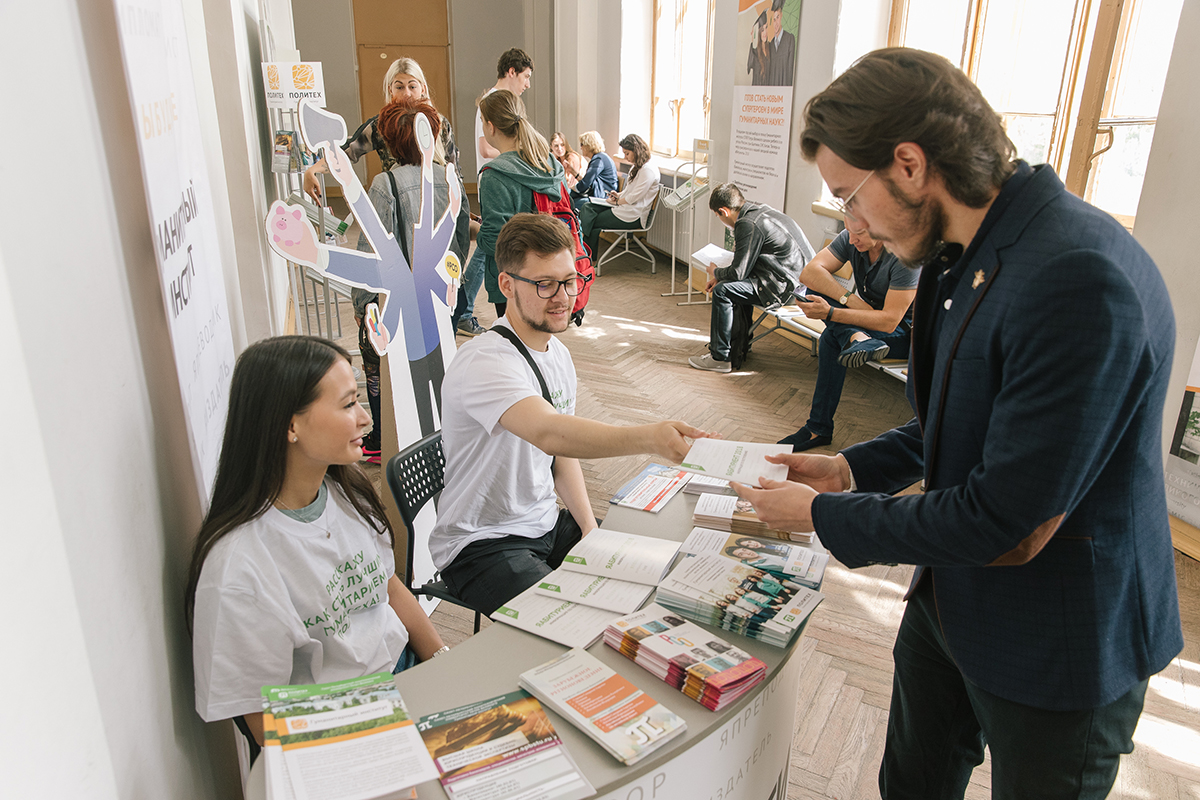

{"left": 442, "top": 509, "right": 582, "bottom": 615}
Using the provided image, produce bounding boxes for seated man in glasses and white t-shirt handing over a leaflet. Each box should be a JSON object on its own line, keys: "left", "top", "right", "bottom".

{"left": 430, "top": 213, "right": 708, "bottom": 614}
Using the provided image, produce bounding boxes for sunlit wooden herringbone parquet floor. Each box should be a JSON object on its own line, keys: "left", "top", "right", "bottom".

{"left": 338, "top": 245, "right": 1200, "bottom": 800}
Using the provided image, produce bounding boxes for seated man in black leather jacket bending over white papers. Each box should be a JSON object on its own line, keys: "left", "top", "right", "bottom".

{"left": 688, "top": 184, "right": 812, "bottom": 372}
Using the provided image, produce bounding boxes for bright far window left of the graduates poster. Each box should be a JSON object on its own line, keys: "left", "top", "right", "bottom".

{"left": 649, "top": 0, "right": 715, "bottom": 156}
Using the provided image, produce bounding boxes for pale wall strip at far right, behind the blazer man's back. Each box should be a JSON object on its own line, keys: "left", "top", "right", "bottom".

{"left": 1133, "top": 2, "right": 1200, "bottom": 453}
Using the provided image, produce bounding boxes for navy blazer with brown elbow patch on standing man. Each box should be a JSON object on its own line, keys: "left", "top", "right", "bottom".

{"left": 812, "top": 162, "right": 1183, "bottom": 709}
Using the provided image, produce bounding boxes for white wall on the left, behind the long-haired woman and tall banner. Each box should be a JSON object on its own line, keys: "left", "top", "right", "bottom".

{"left": 0, "top": 0, "right": 290, "bottom": 800}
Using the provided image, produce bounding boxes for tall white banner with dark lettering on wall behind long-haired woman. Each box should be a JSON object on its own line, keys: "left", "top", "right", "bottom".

{"left": 115, "top": 0, "right": 235, "bottom": 507}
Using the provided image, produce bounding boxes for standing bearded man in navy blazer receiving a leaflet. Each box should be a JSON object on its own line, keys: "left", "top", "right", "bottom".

{"left": 739, "top": 48, "right": 1183, "bottom": 800}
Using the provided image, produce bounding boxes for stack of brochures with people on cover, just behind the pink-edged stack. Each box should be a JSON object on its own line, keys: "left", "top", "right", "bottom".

{"left": 658, "top": 554, "right": 824, "bottom": 648}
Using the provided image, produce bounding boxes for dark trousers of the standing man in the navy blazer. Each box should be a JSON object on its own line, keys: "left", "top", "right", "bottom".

{"left": 880, "top": 576, "right": 1148, "bottom": 800}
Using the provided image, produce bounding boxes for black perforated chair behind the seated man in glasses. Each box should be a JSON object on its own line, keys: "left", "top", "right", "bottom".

{"left": 386, "top": 431, "right": 481, "bottom": 633}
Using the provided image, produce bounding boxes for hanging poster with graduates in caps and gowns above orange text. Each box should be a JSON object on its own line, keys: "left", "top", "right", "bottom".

{"left": 730, "top": 0, "right": 802, "bottom": 210}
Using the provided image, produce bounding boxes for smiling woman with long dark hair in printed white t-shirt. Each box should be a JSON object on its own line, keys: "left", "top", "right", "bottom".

{"left": 186, "top": 336, "right": 446, "bottom": 744}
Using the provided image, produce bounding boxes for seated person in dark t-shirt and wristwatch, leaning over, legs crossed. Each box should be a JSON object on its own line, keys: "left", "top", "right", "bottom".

{"left": 779, "top": 217, "right": 920, "bottom": 452}
